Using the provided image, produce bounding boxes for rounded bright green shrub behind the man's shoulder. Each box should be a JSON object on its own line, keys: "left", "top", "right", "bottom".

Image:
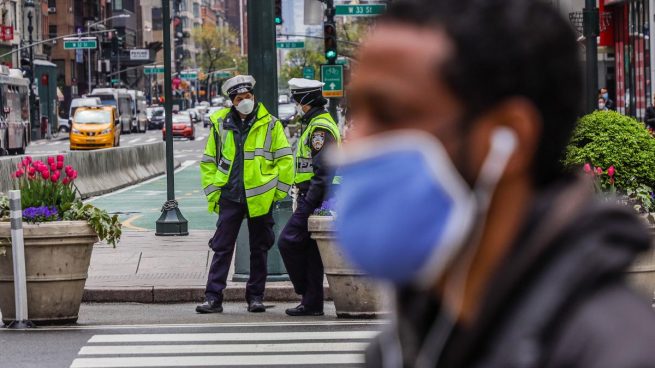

{"left": 564, "top": 111, "right": 655, "bottom": 194}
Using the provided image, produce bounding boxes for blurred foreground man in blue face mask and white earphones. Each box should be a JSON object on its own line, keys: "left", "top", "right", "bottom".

{"left": 336, "top": 0, "right": 655, "bottom": 368}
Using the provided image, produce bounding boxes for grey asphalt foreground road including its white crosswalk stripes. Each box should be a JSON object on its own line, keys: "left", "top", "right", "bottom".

{"left": 0, "top": 303, "right": 385, "bottom": 368}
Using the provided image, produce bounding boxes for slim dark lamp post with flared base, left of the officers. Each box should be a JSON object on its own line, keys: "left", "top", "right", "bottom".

{"left": 157, "top": 0, "right": 189, "bottom": 236}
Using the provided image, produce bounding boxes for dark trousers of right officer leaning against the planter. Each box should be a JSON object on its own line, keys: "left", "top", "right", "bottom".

{"left": 278, "top": 197, "right": 323, "bottom": 311}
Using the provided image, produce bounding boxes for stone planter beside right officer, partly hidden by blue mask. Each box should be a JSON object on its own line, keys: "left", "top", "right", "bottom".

{"left": 309, "top": 216, "right": 387, "bottom": 318}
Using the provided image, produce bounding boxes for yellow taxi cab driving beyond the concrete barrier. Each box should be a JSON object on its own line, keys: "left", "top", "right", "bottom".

{"left": 70, "top": 106, "right": 121, "bottom": 150}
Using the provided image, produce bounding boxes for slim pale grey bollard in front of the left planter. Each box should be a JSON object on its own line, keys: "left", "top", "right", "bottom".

{"left": 7, "top": 190, "right": 34, "bottom": 329}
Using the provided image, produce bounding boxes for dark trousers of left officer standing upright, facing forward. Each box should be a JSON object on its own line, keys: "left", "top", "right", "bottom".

{"left": 205, "top": 199, "right": 275, "bottom": 302}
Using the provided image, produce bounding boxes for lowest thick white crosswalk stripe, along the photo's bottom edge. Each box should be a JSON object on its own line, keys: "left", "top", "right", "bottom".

{"left": 71, "top": 354, "right": 364, "bottom": 368}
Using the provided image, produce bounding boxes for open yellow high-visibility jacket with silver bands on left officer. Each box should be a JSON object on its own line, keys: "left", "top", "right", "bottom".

{"left": 200, "top": 103, "right": 294, "bottom": 217}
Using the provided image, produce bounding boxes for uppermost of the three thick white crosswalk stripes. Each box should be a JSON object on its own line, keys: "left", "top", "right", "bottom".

{"left": 89, "top": 331, "right": 378, "bottom": 344}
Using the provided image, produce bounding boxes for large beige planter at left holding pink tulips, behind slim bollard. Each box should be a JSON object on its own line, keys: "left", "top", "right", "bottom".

{"left": 0, "top": 221, "right": 98, "bottom": 324}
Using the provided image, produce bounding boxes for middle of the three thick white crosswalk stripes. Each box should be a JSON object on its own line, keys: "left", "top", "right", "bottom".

{"left": 79, "top": 342, "right": 368, "bottom": 355}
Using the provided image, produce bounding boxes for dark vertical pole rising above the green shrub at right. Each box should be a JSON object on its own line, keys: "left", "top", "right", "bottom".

{"left": 583, "top": 0, "right": 600, "bottom": 113}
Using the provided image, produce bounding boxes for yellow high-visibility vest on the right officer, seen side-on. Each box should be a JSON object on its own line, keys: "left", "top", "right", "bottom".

{"left": 294, "top": 112, "right": 341, "bottom": 184}
